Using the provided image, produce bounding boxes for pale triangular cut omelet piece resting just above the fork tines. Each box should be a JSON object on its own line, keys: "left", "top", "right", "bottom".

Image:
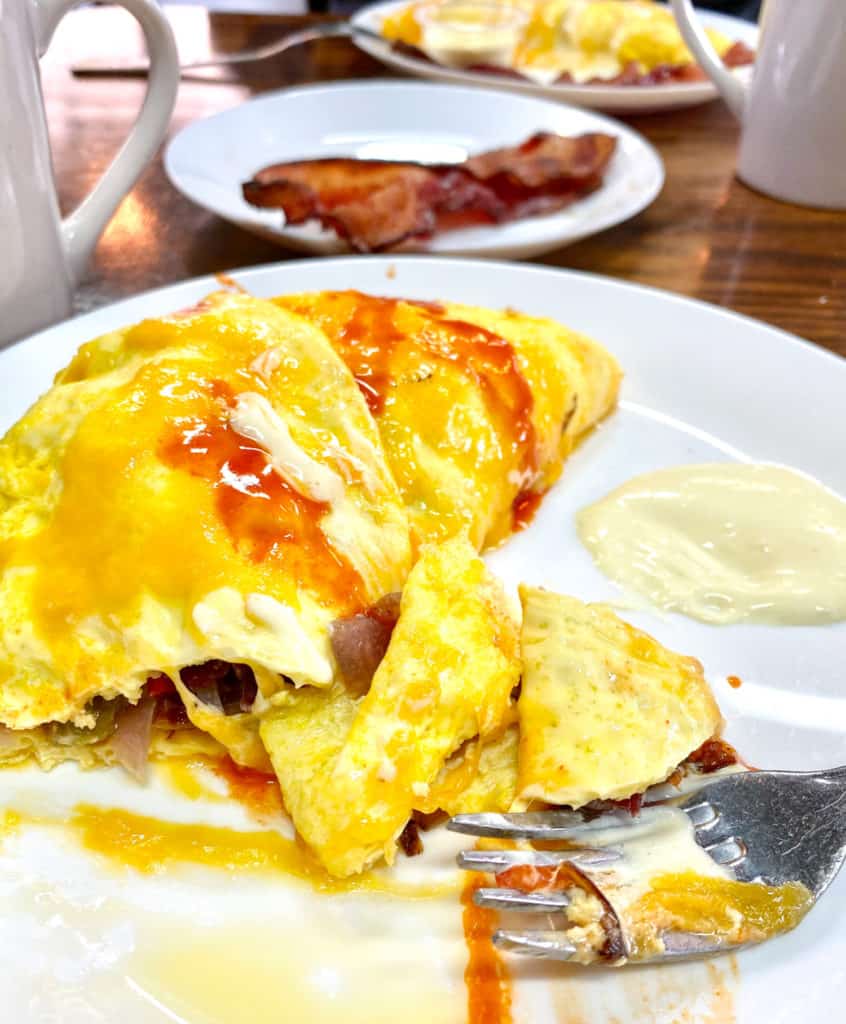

{"left": 517, "top": 586, "right": 721, "bottom": 807}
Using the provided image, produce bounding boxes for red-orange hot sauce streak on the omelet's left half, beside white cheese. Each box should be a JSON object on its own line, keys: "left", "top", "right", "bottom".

{"left": 159, "top": 381, "right": 364, "bottom": 606}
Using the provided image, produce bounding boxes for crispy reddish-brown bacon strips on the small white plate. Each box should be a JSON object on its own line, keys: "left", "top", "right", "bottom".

{"left": 243, "top": 132, "right": 617, "bottom": 252}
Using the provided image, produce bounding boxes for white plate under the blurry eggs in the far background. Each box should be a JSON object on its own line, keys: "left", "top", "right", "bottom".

{"left": 352, "top": 0, "right": 758, "bottom": 114}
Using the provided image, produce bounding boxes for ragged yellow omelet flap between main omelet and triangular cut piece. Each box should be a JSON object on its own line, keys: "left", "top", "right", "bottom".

{"left": 261, "top": 537, "right": 520, "bottom": 876}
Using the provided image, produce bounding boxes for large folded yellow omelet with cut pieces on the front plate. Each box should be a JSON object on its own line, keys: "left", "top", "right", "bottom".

{"left": 8, "top": 292, "right": 733, "bottom": 888}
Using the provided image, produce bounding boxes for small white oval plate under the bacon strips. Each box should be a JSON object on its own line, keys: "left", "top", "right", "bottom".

{"left": 165, "top": 82, "right": 664, "bottom": 259}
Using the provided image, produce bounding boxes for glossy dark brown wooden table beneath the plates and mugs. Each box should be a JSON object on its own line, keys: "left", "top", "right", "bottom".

{"left": 44, "top": 8, "right": 846, "bottom": 355}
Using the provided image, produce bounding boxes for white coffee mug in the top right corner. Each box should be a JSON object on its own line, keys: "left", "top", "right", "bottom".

{"left": 672, "top": 0, "right": 846, "bottom": 210}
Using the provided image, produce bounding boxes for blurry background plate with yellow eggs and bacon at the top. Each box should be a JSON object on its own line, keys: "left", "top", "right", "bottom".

{"left": 353, "top": 0, "right": 758, "bottom": 113}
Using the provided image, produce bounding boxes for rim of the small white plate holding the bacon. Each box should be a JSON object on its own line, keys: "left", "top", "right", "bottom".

{"left": 163, "top": 77, "right": 667, "bottom": 259}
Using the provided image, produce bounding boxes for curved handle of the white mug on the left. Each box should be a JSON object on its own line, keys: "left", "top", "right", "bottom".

{"left": 32, "top": 0, "right": 179, "bottom": 281}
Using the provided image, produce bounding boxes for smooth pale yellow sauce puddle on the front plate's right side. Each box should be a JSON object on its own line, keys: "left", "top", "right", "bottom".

{"left": 578, "top": 463, "right": 846, "bottom": 626}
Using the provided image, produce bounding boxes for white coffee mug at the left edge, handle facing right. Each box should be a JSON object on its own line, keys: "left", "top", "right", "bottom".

{"left": 0, "top": 0, "right": 179, "bottom": 345}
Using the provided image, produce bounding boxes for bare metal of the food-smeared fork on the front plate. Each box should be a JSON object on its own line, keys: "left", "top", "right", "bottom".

{"left": 447, "top": 767, "right": 846, "bottom": 963}
